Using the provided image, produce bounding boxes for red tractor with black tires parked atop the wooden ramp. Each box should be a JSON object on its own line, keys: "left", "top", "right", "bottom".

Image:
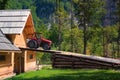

{"left": 27, "top": 33, "right": 52, "bottom": 50}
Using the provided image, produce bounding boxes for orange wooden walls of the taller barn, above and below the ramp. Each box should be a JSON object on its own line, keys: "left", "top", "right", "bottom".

{"left": 4, "top": 14, "right": 36, "bottom": 71}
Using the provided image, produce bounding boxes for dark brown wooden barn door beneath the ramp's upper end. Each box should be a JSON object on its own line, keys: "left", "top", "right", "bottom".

{"left": 14, "top": 53, "right": 24, "bottom": 74}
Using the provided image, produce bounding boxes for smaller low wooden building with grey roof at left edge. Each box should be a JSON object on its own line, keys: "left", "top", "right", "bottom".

{"left": 0, "top": 30, "right": 20, "bottom": 79}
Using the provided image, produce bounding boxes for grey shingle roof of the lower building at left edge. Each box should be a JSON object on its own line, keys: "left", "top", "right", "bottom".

{"left": 0, "top": 30, "right": 20, "bottom": 51}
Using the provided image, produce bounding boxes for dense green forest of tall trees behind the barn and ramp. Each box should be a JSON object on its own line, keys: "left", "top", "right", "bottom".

{"left": 0, "top": 0, "right": 120, "bottom": 58}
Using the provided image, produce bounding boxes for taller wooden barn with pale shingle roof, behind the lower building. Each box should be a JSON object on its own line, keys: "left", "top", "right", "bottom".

{"left": 0, "top": 9, "right": 36, "bottom": 76}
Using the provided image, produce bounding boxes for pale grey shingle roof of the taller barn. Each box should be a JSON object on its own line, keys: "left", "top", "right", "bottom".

{"left": 0, "top": 9, "right": 31, "bottom": 34}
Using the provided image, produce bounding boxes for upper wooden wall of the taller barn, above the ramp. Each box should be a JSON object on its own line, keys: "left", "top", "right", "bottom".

{"left": 6, "top": 15, "right": 34, "bottom": 47}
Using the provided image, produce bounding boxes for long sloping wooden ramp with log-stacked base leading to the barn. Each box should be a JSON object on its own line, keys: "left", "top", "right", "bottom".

{"left": 20, "top": 48, "right": 120, "bottom": 69}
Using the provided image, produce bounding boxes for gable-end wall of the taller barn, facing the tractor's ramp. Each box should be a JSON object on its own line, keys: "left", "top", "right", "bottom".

{"left": 22, "top": 15, "right": 36, "bottom": 72}
